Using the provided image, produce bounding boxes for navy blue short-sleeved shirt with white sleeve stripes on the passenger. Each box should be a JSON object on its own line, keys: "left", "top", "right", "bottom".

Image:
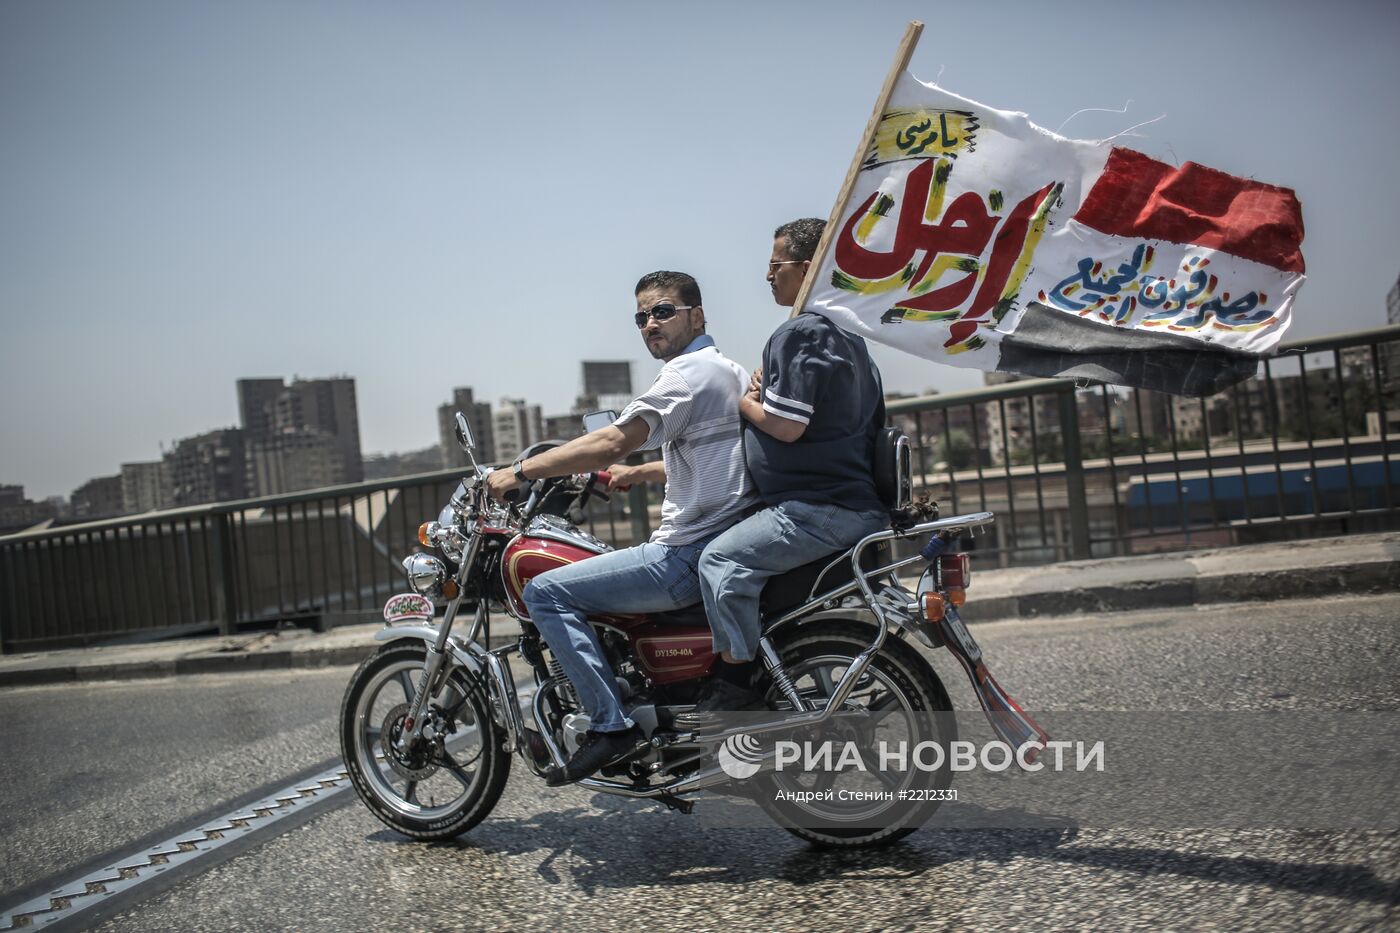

{"left": 743, "top": 311, "right": 885, "bottom": 510}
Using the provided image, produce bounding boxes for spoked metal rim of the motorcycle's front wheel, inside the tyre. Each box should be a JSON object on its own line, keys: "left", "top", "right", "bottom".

{"left": 354, "top": 654, "right": 487, "bottom": 821}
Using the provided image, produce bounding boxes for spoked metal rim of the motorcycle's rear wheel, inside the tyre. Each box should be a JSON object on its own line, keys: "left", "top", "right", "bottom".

{"left": 773, "top": 654, "right": 927, "bottom": 825}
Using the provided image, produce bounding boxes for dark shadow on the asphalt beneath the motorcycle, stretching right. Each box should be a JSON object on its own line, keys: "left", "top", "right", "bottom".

{"left": 370, "top": 794, "right": 1400, "bottom": 904}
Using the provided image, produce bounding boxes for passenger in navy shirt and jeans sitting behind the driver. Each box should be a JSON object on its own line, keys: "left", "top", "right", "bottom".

{"left": 676, "top": 219, "right": 889, "bottom": 728}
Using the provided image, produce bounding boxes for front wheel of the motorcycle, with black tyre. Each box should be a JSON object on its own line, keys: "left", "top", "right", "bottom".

{"left": 340, "top": 642, "right": 511, "bottom": 841}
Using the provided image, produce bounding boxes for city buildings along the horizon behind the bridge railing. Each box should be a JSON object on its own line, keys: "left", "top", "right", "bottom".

{"left": 13, "top": 342, "right": 1400, "bottom": 518}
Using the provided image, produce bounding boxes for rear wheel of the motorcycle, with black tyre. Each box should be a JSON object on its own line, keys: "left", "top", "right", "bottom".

{"left": 755, "top": 619, "right": 958, "bottom": 849}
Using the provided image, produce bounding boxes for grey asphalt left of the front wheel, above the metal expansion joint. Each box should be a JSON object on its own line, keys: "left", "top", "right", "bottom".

{"left": 0, "top": 668, "right": 349, "bottom": 906}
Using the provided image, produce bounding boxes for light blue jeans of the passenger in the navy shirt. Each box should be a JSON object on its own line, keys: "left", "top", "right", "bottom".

{"left": 700, "top": 502, "right": 889, "bottom": 661}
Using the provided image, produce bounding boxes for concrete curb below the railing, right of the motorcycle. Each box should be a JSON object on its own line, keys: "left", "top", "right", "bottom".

{"left": 965, "top": 560, "right": 1400, "bottom": 622}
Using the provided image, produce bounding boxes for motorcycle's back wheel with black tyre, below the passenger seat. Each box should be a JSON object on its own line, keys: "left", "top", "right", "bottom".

{"left": 756, "top": 619, "right": 958, "bottom": 849}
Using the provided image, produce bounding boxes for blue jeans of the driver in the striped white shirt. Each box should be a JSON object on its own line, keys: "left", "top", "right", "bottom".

{"left": 522, "top": 541, "right": 706, "bottom": 733}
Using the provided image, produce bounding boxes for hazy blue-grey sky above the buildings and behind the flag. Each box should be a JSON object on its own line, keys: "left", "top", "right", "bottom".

{"left": 0, "top": 0, "right": 1400, "bottom": 499}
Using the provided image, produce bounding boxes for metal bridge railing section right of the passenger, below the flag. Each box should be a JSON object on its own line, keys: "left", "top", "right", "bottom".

{"left": 886, "top": 326, "right": 1400, "bottom": 566}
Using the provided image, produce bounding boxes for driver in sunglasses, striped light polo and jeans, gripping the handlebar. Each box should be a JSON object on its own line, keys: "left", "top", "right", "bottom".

{"left": 487, "top": 272, "right": 755, "bottom": 785}
